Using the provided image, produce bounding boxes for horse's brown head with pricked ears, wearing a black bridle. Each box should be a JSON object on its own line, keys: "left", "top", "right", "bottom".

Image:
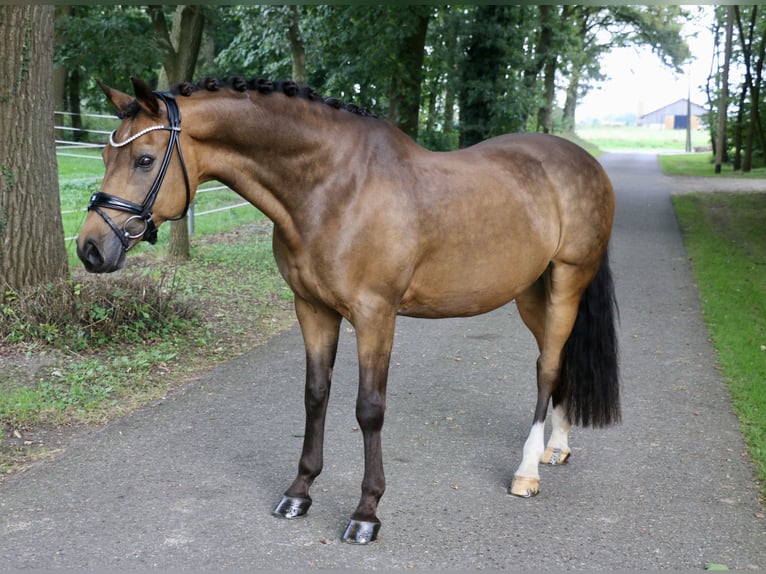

{"left": 77, "top": 78, "right": 194, "bottom": 273}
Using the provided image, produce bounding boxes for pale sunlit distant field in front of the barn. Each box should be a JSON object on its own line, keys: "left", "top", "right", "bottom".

{"left": 575, "top": 126, "right": 710, "bottom": 152}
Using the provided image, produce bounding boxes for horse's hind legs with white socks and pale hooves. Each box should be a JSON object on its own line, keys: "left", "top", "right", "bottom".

{"left": 509, "top": 264, "right": 590, "bottom": 497}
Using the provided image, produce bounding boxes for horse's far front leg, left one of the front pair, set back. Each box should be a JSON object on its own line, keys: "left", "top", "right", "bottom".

{"left": 274, "top": 297, "right": 341, "bottom": 518}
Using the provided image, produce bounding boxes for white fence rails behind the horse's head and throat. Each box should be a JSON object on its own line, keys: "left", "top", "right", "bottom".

{"left": 54, "top": 112, "right": 250, "bottom": 241}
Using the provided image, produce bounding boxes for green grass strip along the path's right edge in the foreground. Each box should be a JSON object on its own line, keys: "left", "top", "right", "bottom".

{"left": 673, "top": 193, "right": 766, "bottom": 496}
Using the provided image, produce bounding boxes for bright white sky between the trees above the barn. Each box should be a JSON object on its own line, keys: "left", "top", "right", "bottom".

{"left": 576, "top": 6, "right": 713, "bottom": 123}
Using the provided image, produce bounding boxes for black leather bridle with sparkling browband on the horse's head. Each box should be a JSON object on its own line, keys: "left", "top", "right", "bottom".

{"left": 88, "top": 92, "right": 191, "bottom": 251}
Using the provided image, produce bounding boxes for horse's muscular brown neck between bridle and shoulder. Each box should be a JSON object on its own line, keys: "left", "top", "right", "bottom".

{"left": 190, "top": 94, "right": 354, "bottom": 248}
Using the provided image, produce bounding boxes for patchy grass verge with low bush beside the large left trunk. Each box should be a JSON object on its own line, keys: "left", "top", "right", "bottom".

{"left": 0, "top": 220, "right": 294, "bottom": 479}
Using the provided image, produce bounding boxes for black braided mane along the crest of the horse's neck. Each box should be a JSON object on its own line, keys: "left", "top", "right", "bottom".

{"left": 118, "top": 76, "right": 379, "bottom": 118}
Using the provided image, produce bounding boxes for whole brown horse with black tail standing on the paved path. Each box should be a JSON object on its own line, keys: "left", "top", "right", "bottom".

{"left": 77, "top": 76, "right": 621, "bottom": 544}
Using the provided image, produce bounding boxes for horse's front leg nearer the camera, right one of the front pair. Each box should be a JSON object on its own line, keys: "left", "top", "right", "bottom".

{"left": 342, "top": 310, "right": 396, "bottom": 544}
